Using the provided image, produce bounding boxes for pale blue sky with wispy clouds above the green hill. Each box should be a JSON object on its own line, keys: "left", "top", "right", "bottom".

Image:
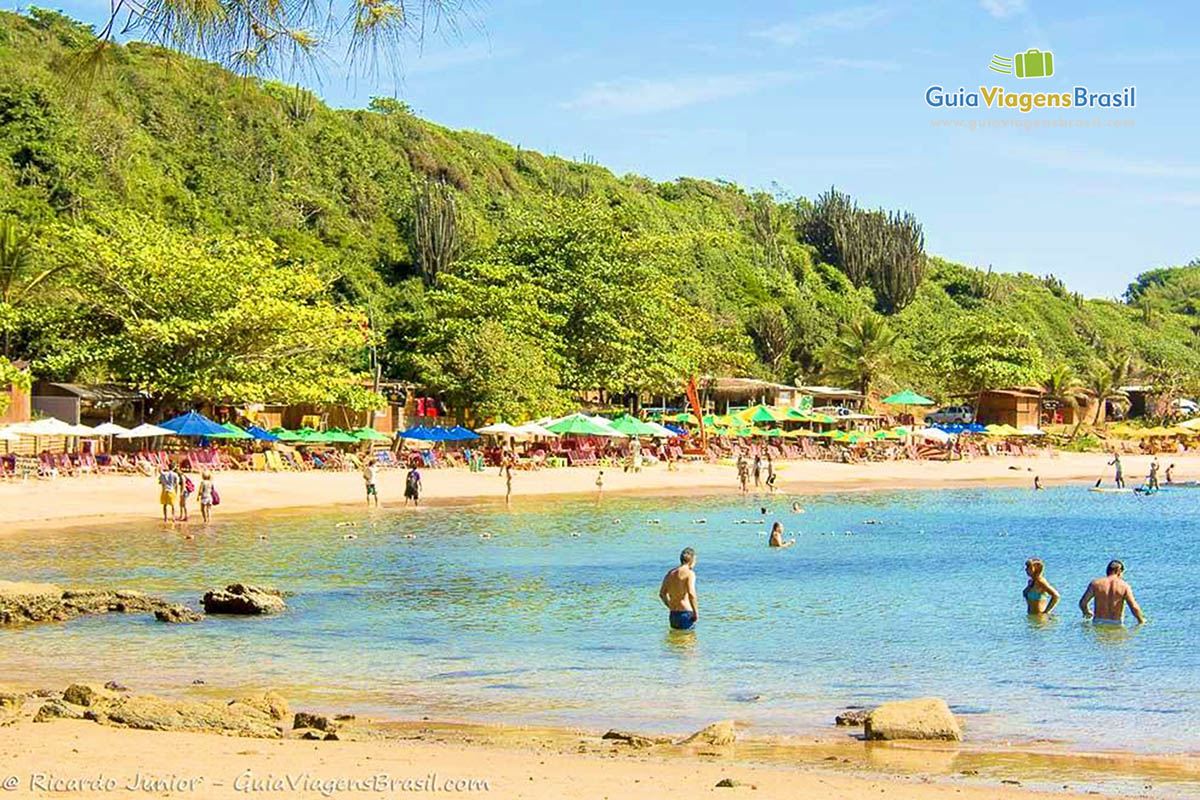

{"left": 25, "top": 0, "right": 1200, "bottom": 296}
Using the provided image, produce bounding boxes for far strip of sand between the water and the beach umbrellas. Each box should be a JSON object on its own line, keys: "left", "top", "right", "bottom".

{"left": 0, "top": 452, "right": 1200, "bottom": 532}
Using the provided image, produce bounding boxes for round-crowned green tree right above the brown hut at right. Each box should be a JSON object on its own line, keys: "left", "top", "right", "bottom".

{"left": 940, "top": 319, "right": 1045, "bottom": 395}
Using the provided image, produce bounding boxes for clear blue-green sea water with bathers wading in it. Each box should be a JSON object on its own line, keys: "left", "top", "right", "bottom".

{"left": 0, "top": 487, "right": 1200, "bottom": 752}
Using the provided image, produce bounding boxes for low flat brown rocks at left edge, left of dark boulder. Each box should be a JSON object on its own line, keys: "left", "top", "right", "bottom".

{"left": 0, "top": 582, "right": 170, "bottom": 625}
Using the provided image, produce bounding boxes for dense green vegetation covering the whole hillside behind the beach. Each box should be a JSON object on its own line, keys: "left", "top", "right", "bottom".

{"left": 0, "top": 11, "right": 1200, "bottom": 417}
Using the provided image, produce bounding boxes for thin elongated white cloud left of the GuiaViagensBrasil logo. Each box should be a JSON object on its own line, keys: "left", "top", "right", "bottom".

{"left": 563, "top": 72, "right": 800, "bottom": 114}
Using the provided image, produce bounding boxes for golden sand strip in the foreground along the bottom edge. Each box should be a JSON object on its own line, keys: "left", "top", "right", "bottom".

{"left": 0, "top": 700, "right": 1180, "bottom": 800}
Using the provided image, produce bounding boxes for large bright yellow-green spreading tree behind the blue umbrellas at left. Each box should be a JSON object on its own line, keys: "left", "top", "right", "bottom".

{"left": 29, "top": 215, "right": 379, "bottom": 410}
